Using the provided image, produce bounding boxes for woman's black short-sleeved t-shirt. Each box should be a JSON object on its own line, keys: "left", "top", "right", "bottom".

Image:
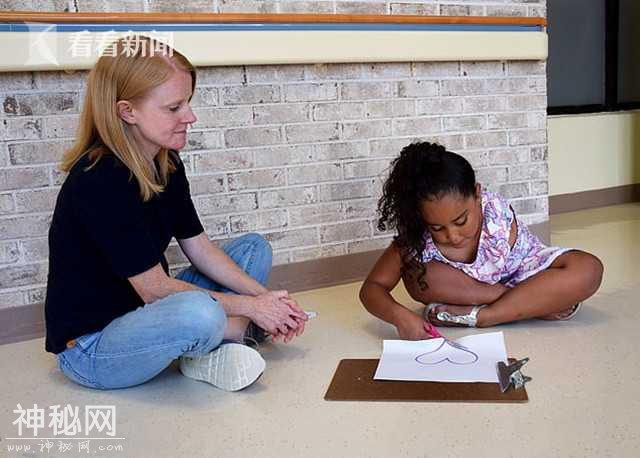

{"left": 45, "top": 152, "right": 203, "bottom": 354}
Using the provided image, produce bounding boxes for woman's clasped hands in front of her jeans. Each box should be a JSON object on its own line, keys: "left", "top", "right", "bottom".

{"left": 249, "top": 290, "right": 308, "bottom": 336}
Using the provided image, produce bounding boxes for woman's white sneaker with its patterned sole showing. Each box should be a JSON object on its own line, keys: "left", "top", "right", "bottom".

{"left": 180, "top": 343, "right": 266, "bottom": 391}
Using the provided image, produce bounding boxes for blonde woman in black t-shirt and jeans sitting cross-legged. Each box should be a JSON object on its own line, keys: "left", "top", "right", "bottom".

{"left": 45, "top": 36, "right": 307, "bottom": 391}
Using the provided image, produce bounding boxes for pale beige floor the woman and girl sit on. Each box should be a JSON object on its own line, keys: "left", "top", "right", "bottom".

{"left": 0, "top": 204, "right": 640, "bottom": 458}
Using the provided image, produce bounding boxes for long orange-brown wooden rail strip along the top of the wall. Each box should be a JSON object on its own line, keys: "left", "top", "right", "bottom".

{"left": 0, "top": 11, "right": 547, "bottom": 26}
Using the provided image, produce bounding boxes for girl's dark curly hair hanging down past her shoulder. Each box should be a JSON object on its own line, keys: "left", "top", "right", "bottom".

{"left": 378, "top": 142, "right": 476, "bottom": 289}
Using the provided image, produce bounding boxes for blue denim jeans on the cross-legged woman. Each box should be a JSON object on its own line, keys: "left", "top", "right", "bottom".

{"left": 57, "top": 234, "right": 271, "bottom": 389}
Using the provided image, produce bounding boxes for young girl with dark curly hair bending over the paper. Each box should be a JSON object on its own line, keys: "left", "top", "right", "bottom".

{"left": 360, "top": 143, "right": 603, "bottom": 340}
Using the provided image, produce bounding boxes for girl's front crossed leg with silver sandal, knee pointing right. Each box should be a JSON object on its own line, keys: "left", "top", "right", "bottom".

{"left": 432, "top": 251, "right": 603, "bottom": 327}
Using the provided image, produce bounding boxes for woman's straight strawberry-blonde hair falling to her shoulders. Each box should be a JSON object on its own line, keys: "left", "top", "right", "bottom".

{"left": 60, "top": 35, "right": 196, "bottom": 202}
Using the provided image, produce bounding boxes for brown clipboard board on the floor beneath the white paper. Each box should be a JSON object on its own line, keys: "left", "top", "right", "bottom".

{"left": 324, "top": 359, "right": 529, "bottom": 403}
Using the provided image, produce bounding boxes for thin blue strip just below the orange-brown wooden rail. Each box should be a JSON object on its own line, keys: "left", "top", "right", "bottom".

{"left": 0, "top": 23, "right": 543, "bottom": 32}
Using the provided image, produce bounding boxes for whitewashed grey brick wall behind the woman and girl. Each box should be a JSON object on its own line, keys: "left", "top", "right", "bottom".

{"left": 0, "top": 0, "right": 548, "bottom": 308}
